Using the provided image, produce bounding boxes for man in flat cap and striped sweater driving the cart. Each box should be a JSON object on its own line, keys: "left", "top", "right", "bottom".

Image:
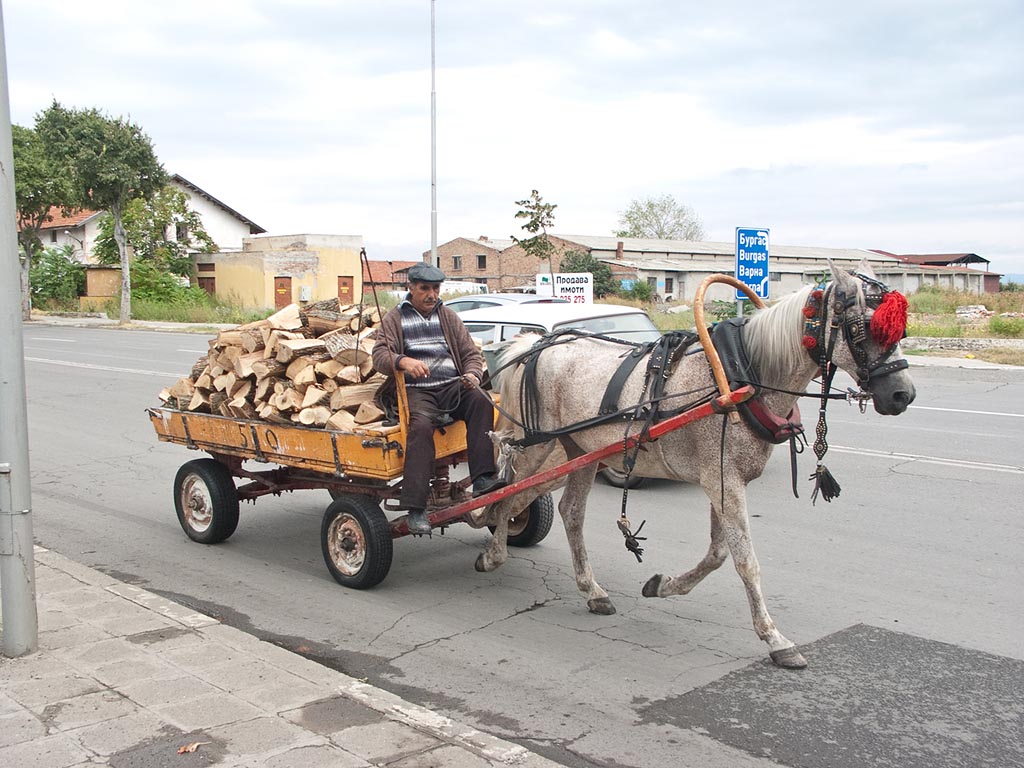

{"left": 373, "top": 263, "right": 505, "bottom": 534}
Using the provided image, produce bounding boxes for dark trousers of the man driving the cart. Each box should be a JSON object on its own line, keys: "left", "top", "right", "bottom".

{"left": 399, "top": 380, "right": 495, "bottom": 509}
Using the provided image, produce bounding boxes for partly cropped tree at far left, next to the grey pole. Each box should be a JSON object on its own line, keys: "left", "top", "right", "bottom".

{"left": 10, "top": 125, "right": 70, "bottom": 319}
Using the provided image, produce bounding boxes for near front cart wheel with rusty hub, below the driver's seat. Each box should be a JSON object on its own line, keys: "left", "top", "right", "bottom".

{"left": 321, "top": 494, "right": 393, "bottom": 590}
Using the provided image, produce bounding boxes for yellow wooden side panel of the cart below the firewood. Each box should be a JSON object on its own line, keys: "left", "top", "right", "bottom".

{"left": 148, "top": 409, "right": 407, "bottom": 480}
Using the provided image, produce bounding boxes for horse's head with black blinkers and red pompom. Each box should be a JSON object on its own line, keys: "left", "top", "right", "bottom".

{"left": 804, "top": 261, "right": 916, "bottom": 416}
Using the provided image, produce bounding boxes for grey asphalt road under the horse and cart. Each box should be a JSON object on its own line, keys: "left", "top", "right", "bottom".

{"left": 16, "top": 325, "right": 1024, "bottom": 768}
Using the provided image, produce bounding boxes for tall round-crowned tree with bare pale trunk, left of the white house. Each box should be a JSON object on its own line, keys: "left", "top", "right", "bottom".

{"left": 36, "top": 100, "right": 167, "bottom": 324}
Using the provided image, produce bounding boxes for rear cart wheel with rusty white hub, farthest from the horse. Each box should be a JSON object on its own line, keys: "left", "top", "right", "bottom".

{"left": 174, "top": 459, "right": 239, "bottom": 544}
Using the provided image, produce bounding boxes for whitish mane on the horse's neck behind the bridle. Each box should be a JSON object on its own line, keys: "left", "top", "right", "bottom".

{"left": 743, "top": 286, "right": 814, "bottom": 384}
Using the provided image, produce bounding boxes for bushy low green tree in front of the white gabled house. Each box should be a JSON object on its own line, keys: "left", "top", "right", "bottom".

{"left": 93, "top": 184, "right": 217, "bottom": 278}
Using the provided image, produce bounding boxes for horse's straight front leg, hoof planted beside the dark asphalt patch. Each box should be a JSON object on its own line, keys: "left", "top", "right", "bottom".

{"left": 712, "top": 482, "right": 807, "bottom": 670}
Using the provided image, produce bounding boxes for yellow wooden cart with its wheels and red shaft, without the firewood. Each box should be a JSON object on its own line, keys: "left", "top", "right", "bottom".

{"left": 147, "top": 366, "right": 754, "bottom": 589}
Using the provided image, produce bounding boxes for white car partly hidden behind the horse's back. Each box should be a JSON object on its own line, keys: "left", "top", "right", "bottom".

{"left": 458, "top": 303, "right": 662, "bottom": 488}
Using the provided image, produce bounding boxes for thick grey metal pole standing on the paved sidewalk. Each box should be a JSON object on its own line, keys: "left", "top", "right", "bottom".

{"left": 0, "top": 5, "right": 39, "bottom": 656}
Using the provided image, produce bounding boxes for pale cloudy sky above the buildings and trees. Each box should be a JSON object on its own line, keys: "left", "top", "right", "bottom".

{"left": 8, "top": 0, "right": 1024, "bottom": 273}
